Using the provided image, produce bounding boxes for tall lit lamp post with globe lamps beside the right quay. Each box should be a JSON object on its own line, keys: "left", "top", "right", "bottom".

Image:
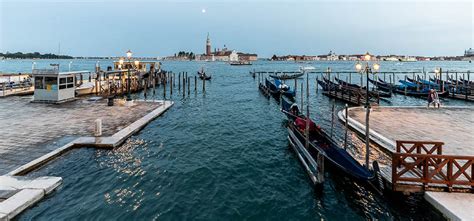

{"left": 355, "top": 52, "right": 380, "bottom": 169}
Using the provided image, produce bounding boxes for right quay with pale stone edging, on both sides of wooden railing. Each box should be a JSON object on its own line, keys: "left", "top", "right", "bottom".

{"left": 338, "top": 107, "right": 474, "bottom": 220}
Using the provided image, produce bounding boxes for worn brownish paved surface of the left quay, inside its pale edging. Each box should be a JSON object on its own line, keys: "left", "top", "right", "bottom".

{"left": 0, "top": 96, "right": 162, "bottom": 175}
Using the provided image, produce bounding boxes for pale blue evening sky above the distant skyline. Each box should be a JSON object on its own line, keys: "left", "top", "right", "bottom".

{"left": 0, "top": 0, "right": 474, "bottom": 57}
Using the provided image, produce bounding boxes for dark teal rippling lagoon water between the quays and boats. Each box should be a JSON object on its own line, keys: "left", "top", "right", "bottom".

{"left": 0, "top": 60, "right": 474, "bottom": 220}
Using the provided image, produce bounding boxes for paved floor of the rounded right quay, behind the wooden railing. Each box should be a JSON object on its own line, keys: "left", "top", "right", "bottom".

{"left": 349, "top": 107, "right": 474, "bottom": 156}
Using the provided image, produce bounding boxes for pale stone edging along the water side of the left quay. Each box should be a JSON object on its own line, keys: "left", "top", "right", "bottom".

{"left": 0, "top": 98, "right": 173, "bottom": 221}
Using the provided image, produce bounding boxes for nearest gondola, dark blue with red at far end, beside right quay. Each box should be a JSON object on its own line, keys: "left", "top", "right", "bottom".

{"left": 282, "top": 99, "right": 375, "bottom": 182}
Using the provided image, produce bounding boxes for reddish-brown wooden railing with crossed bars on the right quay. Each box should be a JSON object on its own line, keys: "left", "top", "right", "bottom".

{"left": 392, "top": 141, "right": 474, "bottom": 192}
